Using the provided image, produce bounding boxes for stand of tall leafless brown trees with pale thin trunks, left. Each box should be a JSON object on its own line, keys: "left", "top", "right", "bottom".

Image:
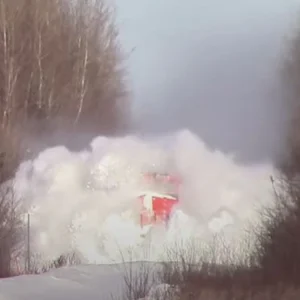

{"left": 0, "top": 0, "right": 129, "bottom": 180}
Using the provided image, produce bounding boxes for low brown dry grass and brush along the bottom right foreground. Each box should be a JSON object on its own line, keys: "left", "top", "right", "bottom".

{"left": 118, "top": 241, "right": 300, "bottom": 300}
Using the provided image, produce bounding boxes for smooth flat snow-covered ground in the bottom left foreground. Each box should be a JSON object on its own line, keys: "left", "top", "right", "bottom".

{"left": 0, "top": 263, "right": 162, "bottom": 300}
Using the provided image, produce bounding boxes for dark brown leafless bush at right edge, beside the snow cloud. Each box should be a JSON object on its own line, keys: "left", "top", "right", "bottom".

{"left": 253, "top": 177, "right": 300, "bottom": 286}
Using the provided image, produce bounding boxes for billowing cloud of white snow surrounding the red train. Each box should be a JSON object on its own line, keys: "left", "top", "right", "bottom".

{"left": 9, "top": 131, "right": 275, "bottom": 266}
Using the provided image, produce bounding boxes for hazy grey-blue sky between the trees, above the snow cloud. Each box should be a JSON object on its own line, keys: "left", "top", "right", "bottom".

{"left": 115, "top": 0, "right": 300, "bottom": 162}
